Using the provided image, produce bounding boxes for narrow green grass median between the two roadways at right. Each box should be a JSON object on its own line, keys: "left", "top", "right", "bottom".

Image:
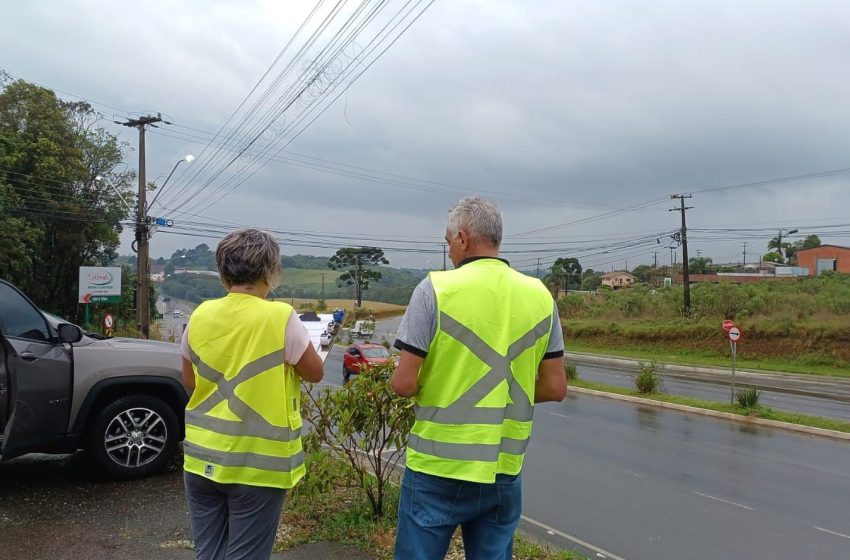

{"left": 571, "top": 379, "right": 850, "bottom": 433}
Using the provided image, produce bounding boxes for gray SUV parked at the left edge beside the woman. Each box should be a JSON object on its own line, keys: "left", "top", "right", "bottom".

{"left": 0, "top": 280, "right": 188, "bottom": 478}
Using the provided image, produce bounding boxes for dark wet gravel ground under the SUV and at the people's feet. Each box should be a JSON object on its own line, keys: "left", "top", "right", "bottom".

{"left": 0, "top": 453, "right": 369, "bottom": 560}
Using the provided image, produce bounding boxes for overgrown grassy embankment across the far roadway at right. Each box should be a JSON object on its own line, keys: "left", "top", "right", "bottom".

{"left": 558, "top": 275, "right": 850, "bottom": 376}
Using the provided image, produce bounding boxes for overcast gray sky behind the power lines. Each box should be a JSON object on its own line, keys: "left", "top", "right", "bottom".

{"left": 6, "top": 0, "right": 850, "bottom": 270}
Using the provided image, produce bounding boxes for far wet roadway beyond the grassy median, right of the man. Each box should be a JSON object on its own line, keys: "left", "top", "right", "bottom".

{"left": 577, "top": 364, "right": 850, "bottom": 420}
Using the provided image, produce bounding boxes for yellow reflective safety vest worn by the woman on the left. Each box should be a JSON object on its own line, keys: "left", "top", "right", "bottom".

{"left": 183, "top": 293, "right": 304, "bottom": 488}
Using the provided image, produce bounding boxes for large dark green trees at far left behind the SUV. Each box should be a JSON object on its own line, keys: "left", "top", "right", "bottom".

{"left": 0, "top": 72, "right": 143, "bottom": 321}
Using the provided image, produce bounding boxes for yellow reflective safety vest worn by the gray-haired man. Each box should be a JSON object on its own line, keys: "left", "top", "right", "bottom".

{"left": 407, "top": 258, "right": 554, "bottom": 483}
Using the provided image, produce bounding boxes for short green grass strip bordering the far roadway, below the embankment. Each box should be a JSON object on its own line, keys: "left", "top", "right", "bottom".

{"left": 567, "top": 339, "right": 850, "bottom": 377}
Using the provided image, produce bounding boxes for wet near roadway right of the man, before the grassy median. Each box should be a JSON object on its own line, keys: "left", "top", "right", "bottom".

{"left": 523, "top": 395, "right": 850, "bottom": 560}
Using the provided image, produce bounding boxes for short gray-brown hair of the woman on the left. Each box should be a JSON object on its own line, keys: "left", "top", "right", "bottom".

{"left": 215, "top": 228, "right": 282, "bottom": 289}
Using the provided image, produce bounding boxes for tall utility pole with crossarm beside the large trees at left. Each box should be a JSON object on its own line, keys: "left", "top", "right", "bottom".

{"left": 121, "top": 114, "right": 163, "bottom": 338}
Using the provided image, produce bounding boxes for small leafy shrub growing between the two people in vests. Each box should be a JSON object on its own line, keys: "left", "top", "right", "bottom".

{"left": 301, "top": 365, "right": 414, "bottom": 519}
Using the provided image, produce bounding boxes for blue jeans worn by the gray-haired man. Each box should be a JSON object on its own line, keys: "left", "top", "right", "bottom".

{"left": 395, "top": 469, "right": 522, "bottom": 560}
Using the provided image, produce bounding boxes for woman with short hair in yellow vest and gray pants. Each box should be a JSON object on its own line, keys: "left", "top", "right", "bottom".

{"left": 183, "top": 229, "right": 324, "bottom": 560}
